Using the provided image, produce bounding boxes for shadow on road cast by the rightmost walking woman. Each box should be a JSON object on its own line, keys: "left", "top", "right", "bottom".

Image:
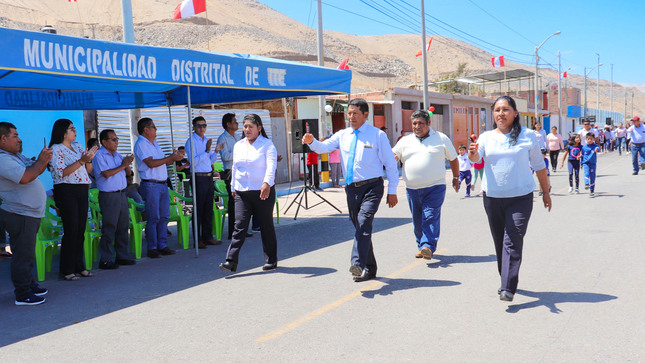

{"left": 506, "top": 290, "right": 618, "bottom": 314}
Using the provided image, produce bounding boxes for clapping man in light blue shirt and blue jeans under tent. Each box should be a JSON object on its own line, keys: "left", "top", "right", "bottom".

{"left": 134, "top": 117, "right": 184, "bottom": 258}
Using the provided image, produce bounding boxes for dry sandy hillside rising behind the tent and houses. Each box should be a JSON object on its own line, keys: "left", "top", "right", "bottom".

{"left": 0, "top": 0, "right": 645, "bottom": 116}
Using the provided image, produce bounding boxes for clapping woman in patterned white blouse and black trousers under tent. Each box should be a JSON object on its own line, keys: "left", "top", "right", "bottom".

{"left": 49, "top": 119, "right": 97, "bottom": 281}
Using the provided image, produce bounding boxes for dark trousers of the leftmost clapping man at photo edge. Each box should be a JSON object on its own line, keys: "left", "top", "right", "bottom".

{"left": 0, "top": 209, "right": 40, "bottom": 300}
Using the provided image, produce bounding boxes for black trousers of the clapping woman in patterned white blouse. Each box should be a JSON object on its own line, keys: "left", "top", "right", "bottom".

{"left": 54, "top": 184, "right": 89, "bottom": 275}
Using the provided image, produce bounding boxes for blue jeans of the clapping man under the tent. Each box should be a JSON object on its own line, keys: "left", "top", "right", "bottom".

{"left": 139, "top": 181, "right": 170, "bottom": 251}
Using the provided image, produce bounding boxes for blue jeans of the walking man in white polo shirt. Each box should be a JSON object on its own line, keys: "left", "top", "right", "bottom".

{"left": 406, "top": 185, "right": 446, "bottom": 252}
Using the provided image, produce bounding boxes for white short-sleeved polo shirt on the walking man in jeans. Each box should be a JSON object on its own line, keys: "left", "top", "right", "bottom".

{"left": 392, "top": 128, "right": 457, "bottom": 189}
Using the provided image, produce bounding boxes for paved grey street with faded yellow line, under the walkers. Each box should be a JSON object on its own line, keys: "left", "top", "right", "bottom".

{"left": 0, "top": 152, "right": 645, "bottom": 362}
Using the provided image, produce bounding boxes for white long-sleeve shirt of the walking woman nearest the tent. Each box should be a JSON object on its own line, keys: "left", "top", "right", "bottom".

{"left": 231, "top": 135, "right": 278, "bottom": 192}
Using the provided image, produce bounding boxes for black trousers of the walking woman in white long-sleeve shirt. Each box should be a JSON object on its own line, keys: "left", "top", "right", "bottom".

{"left": 226, "top": 186, "right": 278, "bottom": 263}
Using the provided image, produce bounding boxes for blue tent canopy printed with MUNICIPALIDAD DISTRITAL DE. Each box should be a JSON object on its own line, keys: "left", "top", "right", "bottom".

{"left": 0, "top": 28, "right": 351, "bottom": 110}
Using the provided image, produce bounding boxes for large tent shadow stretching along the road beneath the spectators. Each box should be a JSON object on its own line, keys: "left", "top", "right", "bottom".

{"left": 0, "top": 215, "right": 410, "bottom": 347}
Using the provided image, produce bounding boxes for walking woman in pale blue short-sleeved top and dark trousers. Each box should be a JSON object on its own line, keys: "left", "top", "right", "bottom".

{"left": 468, "top": 96, "right": 551, "bottom": 301}
